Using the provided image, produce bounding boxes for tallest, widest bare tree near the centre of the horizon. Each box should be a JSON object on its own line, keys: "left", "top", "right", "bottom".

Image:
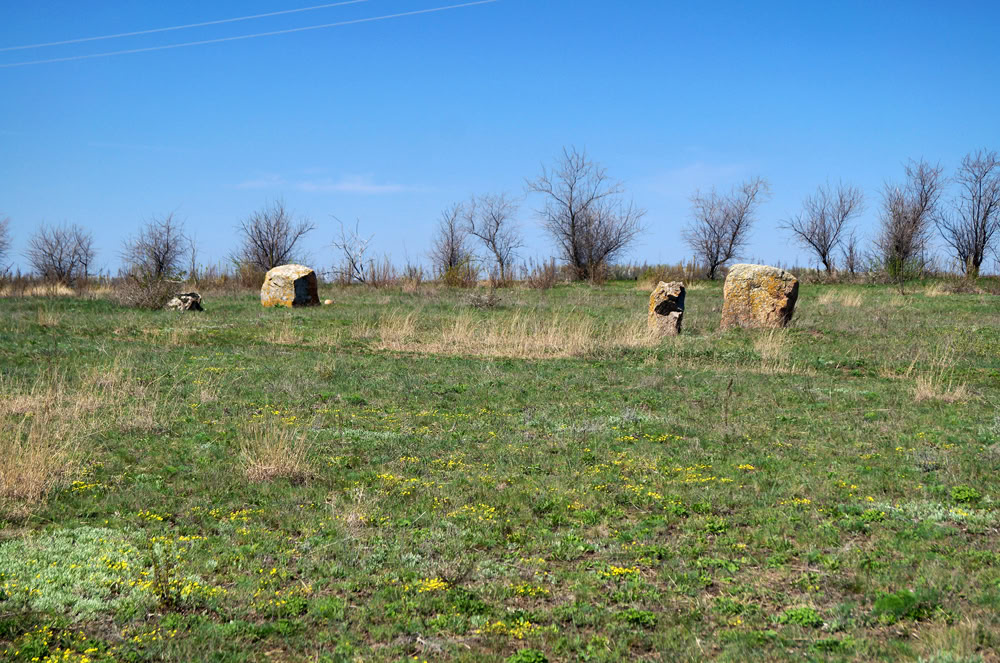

{"left": 527, "top": 147, "right": 646, "bottom": 279}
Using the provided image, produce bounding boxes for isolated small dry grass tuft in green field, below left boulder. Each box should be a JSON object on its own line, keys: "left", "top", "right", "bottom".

{"left": 240, "top": 421, "right": 312, "bottom": 483}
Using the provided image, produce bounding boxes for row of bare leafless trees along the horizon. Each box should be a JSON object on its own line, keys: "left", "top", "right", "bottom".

{"left": 0, "top": 147, "right": 1000, "bottom": 284}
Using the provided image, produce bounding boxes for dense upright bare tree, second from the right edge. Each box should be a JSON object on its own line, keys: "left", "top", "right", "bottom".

{"left": 875, "top": 160, "right": 944, "bottom": 291}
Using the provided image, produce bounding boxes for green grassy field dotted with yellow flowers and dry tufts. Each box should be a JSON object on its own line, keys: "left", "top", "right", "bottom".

{"left": 0, "top": 283, "right": 1000, "bottom": 663}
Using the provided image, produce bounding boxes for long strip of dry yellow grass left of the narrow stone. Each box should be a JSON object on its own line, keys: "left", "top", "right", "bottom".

{"left": 359, "top": 312, "right": 659, "bottom": 359}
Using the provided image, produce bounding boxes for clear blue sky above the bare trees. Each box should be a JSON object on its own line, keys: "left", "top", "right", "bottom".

{"left": 0, "top": 0, "right": 1000, "bottom": 271}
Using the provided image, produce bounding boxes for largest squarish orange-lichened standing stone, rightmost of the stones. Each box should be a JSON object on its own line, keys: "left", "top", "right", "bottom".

{"left": 722, "top": 265, "right": 799, "bottom": 329}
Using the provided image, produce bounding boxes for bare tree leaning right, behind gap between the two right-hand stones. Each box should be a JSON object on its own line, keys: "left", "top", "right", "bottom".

{"left": 682, "top": 177, "right": 771, "bottom": 279}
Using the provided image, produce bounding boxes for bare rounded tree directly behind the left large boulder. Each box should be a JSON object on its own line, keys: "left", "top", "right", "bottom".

{"left": 233, "top": 200, "right": 316, "bottom": 271}
